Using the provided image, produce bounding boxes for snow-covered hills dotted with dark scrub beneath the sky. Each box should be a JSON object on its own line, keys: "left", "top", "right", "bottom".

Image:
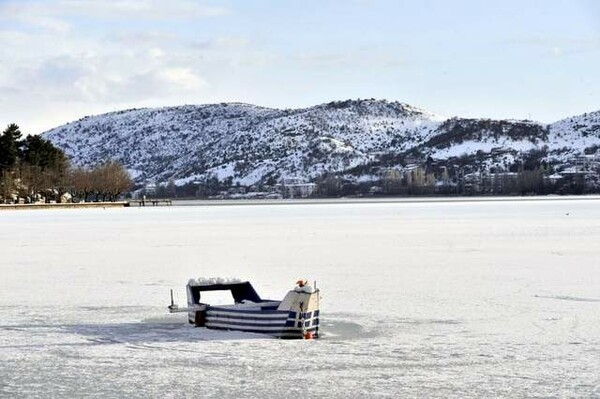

{"left": 44, "top": 100, "right": 600, "bottom": 185}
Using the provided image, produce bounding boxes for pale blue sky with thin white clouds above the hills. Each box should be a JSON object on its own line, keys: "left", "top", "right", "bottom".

{"left": 0, "top": 0, "right": 600, "bottom": 134}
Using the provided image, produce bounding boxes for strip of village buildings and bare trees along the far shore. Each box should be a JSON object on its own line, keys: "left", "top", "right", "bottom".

{"left": 134, "top": 155, "right": 600, "bottom": 199}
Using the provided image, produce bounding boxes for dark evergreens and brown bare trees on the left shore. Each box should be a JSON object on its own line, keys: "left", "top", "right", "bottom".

{"left": 0, "top": 123, "right": 133, "bottom": 203}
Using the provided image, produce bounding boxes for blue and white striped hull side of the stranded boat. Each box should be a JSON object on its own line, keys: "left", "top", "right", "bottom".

{"left": 206, "top": 306, "right": 319, "bottom": 338}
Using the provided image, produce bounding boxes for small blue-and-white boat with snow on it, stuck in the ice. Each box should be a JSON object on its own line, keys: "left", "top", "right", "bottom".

{"left": 168, "top": 278, "right": 320, "bottom": 339}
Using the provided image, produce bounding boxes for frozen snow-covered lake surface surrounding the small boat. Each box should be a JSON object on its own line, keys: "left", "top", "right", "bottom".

{"left": 0, "top": 199, "right": 600, "bottom": 398}
